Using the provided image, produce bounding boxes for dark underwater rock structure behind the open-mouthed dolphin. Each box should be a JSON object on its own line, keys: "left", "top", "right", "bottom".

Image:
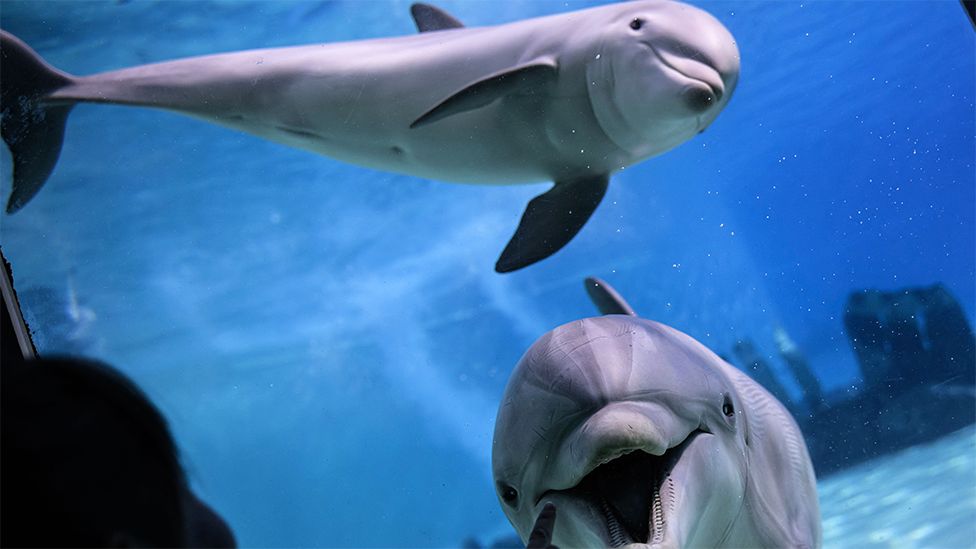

{"left": 732, "top": 284, "right": 976, "bottom": 476}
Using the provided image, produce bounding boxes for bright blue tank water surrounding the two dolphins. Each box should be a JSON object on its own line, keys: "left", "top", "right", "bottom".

{"left": 0, "top": 0, "right": 976, "bottom": 547}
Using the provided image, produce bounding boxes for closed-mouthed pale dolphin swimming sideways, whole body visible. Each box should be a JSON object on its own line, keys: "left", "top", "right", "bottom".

{"left": 0, "top": 0, "right": 739, "bottom": 272}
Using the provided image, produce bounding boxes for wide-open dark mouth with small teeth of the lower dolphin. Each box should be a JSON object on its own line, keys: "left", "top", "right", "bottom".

{"left": 540, "top": 428, "right": 707, "bottom": 547}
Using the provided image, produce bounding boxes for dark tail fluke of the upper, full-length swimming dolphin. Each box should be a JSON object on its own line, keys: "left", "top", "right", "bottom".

{"left": 0, "top": 31, "right": 74, "bottom": 213}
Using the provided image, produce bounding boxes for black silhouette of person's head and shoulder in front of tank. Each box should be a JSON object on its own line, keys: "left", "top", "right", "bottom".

{"left": 0, "top": 358, "right": 234, "bottom": 547}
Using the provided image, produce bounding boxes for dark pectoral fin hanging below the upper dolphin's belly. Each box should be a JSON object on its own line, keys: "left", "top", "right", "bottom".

{"left": 495, "top": 175, "right": 610, "bottom": 273}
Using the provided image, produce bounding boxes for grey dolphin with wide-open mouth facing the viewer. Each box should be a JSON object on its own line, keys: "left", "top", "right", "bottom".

{"left": 492, "top": 281, "right": 821, "bottom": 548}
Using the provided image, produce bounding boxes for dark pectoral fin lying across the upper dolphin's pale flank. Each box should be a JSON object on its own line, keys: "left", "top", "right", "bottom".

{"left": 410, "top": 60, "right": 556, "bottom": 128}
